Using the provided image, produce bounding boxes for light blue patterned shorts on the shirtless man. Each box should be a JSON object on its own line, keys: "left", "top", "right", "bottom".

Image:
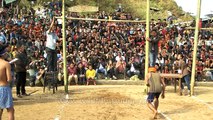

{"left": 0, "top": 86, "right": 13, "bottom": 109}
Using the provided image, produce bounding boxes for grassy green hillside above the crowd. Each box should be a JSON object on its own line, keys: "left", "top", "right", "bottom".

{"left": 19, "top": 0, "right": 191, "bottom": 19}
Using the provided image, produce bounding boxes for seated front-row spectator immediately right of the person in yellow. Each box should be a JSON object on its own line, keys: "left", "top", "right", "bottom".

{"left": 96, "top": 58, "right": 107, "bottom": 79}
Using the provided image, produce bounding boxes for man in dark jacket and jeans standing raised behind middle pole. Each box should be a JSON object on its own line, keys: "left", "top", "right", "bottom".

{"left": 148, "top": 29, "right": 160, "bottom": 67}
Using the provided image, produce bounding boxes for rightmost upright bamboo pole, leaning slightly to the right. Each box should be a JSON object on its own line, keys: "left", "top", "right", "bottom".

{"left": 191, "top": 0, "right": 201, "bottom": 95}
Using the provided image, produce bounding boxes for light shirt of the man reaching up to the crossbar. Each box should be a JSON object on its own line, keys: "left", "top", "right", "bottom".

{"left": 46, "top": 31, "right": 58, "bottom": 50}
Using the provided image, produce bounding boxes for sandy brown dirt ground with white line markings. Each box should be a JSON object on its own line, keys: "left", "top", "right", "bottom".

{"left": 3, "top": 85, "right": 213, "bottom": 120}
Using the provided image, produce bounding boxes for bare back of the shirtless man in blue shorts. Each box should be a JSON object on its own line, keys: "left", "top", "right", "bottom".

{"left": 0, "top": 58, "right": 12, "bottom": 86}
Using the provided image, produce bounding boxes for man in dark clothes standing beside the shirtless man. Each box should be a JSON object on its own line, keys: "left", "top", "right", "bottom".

{"left": 15, "top": 44, "right": 28, "bottom": 97}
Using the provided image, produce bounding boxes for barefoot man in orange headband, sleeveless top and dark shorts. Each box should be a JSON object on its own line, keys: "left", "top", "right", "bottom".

{"left": 145, "top": 67, "right": 165, "bottom": 119}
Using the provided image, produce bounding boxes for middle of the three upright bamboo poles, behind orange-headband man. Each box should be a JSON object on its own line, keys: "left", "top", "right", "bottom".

{"left": 145, "top": 0, "right": 150, "bottom": 92}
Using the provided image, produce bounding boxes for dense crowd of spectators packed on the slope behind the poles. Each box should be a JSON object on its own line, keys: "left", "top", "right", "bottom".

{"left": 0, "top": 2, "right": 213, "bottom": 84}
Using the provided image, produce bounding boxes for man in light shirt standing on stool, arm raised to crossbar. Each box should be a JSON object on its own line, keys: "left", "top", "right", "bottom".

{"left": 46, "top": 18, "right": 59, "bottom": 71}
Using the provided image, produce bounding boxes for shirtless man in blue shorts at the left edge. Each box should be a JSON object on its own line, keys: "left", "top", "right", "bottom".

{"left": 0, "top": 45, "right": 15, "bottom": 120}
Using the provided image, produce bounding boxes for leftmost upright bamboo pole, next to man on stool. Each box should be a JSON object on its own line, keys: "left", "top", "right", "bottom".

{"left": 62, "top": 0, "right": 68, "bottom": 94}
